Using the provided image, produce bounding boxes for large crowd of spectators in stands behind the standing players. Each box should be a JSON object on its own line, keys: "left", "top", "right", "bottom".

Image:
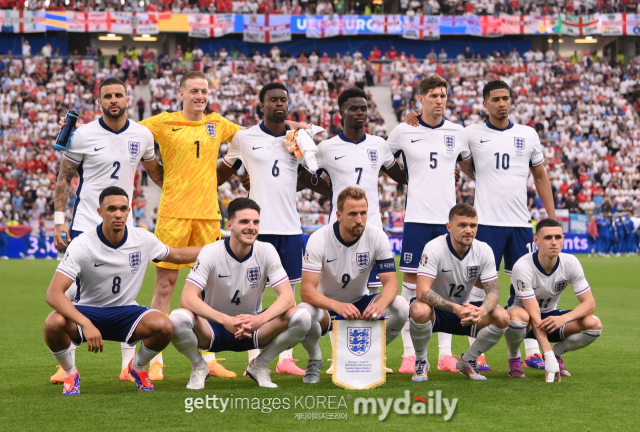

{"left": 0, "top": 46, "right": 640, "bottom": 255}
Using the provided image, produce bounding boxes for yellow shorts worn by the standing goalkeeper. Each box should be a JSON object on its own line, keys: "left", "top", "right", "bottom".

{"left": 153, "top": 217, "right": 221, "bottom": 270}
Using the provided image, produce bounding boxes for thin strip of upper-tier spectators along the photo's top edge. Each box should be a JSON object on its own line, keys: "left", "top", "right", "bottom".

{"left": 6, "top": 0, "right": 639, "bottom": 16}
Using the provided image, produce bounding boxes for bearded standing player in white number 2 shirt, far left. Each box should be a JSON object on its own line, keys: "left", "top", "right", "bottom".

{"left": 51, "top": 78, "right": 163, "bottom": 384}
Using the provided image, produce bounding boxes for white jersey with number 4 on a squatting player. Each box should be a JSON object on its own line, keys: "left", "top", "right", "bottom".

{"left": 187, "top": 238, "right": 289, "bottom": 316}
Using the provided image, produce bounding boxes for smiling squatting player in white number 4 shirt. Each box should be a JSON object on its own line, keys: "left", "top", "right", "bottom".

{"left": 169, "top": 198, "right": 311, "bottom": 390}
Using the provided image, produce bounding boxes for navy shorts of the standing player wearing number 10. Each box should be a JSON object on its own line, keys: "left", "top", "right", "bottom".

{"left": 476, "top": 225, "right": 535, "bottom": 275}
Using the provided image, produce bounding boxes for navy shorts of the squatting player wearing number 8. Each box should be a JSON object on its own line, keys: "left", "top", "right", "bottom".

{"left": 75, "top": 305, "right": 155, "bottom": 345}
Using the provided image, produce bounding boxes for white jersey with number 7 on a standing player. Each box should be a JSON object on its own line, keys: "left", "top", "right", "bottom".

{"left": 316, "top": 132, "right": 396, "bottom": 230}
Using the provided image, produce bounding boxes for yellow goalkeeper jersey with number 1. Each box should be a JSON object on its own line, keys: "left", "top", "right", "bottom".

{"left": 140, "top": 112, "right": 240, "bottom": 220}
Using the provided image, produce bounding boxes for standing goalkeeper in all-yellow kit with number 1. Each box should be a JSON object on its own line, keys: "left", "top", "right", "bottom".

{"left": 140, "top": 71, "right": 310, "bottom": 379}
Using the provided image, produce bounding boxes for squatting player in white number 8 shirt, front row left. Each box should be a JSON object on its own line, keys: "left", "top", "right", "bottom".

{"left": 44, "top": 186, "right": 202, "bottom": 396}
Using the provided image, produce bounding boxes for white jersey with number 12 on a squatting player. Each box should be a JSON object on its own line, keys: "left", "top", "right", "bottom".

{"left": 418, "top": 234, "right": 498, "bottom": 304}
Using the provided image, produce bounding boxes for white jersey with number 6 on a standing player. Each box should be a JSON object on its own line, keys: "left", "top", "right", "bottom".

{"left": 223, "top": 122, "right": 302, "bottom": 235}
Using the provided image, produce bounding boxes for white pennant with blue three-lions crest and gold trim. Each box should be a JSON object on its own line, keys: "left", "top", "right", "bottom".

{"left": 333, "top": 317, "right": 387, "bottom": 390}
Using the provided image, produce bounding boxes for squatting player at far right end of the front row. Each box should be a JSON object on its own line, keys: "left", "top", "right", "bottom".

{"left": 504, "top": 219, "right": 602, "bottom": 381}
